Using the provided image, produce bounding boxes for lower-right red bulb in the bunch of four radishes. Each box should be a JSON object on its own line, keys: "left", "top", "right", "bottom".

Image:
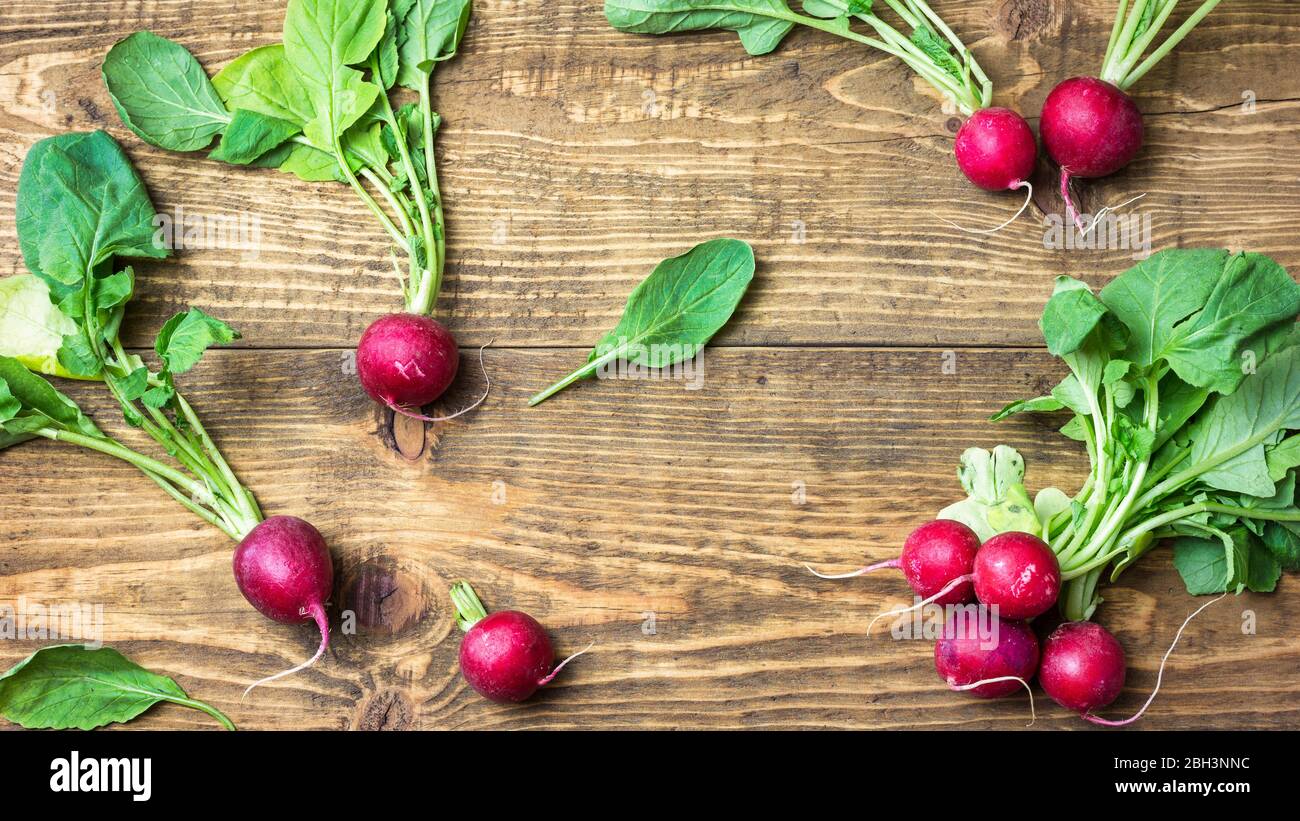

{"left": 1039, "top": 621, "right": 1127, "bottom": 713}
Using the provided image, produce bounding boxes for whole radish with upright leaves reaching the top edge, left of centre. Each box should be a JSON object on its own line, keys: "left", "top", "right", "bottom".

{"left": 103, "top": 0, "right": 486, "bottom": 421}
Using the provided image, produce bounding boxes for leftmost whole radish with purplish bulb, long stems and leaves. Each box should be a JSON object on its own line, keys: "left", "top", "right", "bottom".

{"left": 0, "top": 131, "right": 333, "bottom": 691}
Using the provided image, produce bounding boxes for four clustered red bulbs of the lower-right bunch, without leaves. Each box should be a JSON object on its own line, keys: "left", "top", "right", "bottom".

{"left": 809, "top": 518, "right": 1177, "bottom": 725}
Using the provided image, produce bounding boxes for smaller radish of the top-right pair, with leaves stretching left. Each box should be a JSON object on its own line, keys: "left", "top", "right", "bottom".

{"left": 605, "top": 0, "right": 1037, "bottom": 234}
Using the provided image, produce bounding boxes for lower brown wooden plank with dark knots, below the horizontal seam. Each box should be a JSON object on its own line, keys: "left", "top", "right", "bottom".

{"left": 0, "top": 348, "right": 1300, "bottom": 727}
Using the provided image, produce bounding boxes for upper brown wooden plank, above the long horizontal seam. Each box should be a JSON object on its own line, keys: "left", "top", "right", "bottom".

{"left": 0, "top": 0, "right": 1300, "bottom": 347}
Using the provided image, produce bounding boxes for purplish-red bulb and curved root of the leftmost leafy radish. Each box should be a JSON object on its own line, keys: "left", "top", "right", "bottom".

{"left": 233, "top": 516, "right": 334, "bottom": 695}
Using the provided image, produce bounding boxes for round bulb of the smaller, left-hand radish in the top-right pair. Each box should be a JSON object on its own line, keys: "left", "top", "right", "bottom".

{"left": 953, "top": 108, "right": 1039, "bottom": 191}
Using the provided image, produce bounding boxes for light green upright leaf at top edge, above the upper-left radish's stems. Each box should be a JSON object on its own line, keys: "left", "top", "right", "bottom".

{"left": 285, "top": 0, "right": 386, "bottom": 148}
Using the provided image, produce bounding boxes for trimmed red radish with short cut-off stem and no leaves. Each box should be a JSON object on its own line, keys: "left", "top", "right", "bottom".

{"left": 451, "top": 582, "right": 592, "bottom": 703}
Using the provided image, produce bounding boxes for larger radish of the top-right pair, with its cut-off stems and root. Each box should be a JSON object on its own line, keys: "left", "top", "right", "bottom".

{"left": 1039, "top": 0, "right": 1219, "bottom": 234}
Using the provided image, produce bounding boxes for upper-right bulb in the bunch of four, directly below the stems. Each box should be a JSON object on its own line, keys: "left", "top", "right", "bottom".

{"left": 975, "top": 531, "right": 1061, "bottom": 620}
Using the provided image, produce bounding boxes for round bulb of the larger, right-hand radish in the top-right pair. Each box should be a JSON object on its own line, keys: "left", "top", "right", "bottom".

{"left": 1039, "top": 77, "right": 1143, "bottom": 178}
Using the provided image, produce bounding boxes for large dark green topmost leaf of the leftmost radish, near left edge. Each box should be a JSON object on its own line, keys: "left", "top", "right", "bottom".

{"left": 17, "top": 131, "right": 169, "bottom": 286}
